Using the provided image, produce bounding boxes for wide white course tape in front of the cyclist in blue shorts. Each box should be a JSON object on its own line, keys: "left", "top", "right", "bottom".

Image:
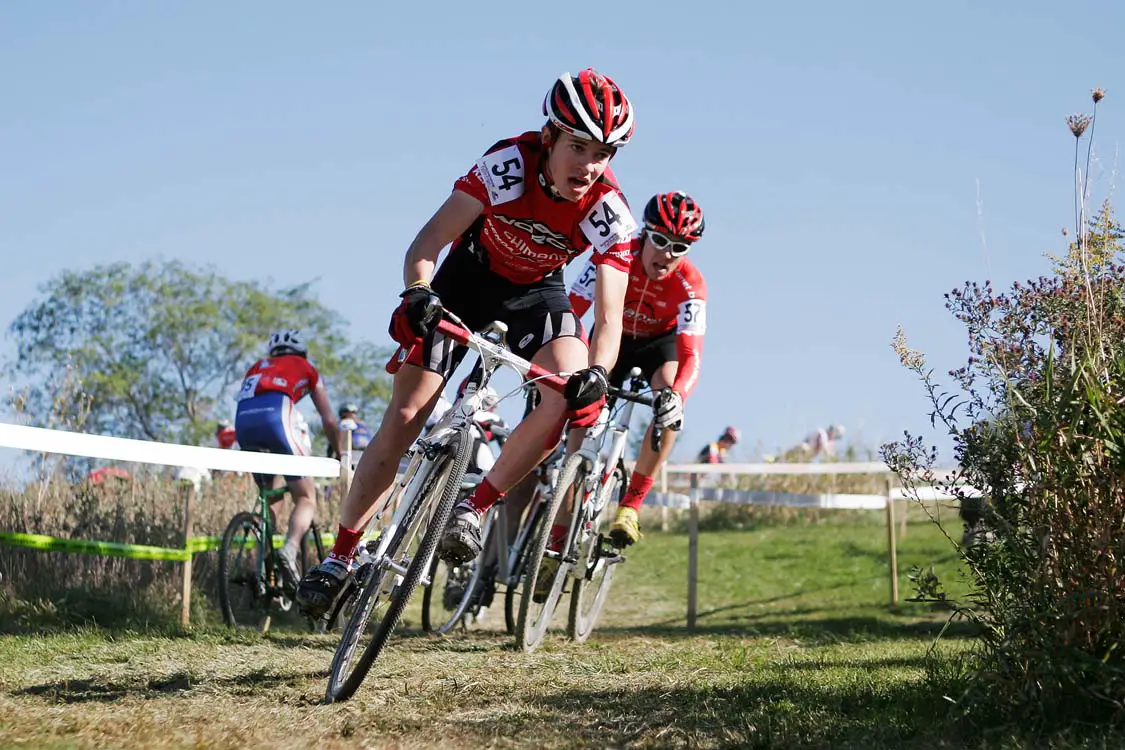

{"left": 0, "top": 422, "right": 340, "bottom": 477}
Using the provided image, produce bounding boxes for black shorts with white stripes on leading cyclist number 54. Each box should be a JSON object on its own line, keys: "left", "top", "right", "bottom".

{"left": 408, "top": 249, "right": 583, "bottom": 379}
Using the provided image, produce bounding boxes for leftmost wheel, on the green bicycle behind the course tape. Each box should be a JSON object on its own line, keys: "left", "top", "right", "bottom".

{"left": 218, "top": 512, "right": 272, "bottom": 627}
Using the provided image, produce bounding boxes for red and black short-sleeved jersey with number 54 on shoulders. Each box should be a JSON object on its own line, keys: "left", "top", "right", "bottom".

{"left": 453, "top": 130, "right": 637, "bottom": 284}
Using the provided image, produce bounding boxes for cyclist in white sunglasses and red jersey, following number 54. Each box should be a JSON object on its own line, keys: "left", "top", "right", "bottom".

{"left": 570, "top": 192, "right": 707, "bottom": 546}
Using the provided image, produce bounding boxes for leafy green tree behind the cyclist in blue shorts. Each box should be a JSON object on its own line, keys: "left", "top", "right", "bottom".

{"left": 5, "top": 261, "right": 389, "bottom": 443}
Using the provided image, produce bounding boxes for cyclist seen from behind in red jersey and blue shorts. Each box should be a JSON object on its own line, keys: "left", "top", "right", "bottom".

{"left": 234, "top": 331, "right": 339, "bottom": 588}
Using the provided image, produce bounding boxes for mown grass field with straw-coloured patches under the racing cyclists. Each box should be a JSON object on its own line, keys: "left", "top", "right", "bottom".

{"left": 0, "top": 518, "right": 1074, "bottom": 750}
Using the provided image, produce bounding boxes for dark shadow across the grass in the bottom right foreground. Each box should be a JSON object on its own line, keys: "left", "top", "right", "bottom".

{"left": 452, "top": 659, "right": 969, "bottom": 748}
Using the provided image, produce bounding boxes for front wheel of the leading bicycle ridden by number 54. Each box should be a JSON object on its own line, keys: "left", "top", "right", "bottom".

{"left": 325, "top": 435, "right": 473, "bottom": 703}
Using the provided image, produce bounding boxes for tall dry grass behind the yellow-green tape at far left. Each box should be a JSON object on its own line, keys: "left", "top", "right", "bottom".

{"left": 0, "top": 474, "right": 339, "bottom": 632}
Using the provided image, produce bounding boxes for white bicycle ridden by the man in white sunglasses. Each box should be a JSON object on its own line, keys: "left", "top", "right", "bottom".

{"left": 515, "top": 368, "right": 663, "bottom": 652}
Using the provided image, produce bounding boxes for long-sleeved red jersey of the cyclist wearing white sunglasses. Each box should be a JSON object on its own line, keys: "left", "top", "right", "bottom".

{"left": 570, "top": 244, "right": 707, "bottom": 398}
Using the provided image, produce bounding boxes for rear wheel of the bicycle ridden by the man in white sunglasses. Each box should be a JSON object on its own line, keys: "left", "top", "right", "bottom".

{"left": 566, "top": 464, "right": 628, "bottom": 643}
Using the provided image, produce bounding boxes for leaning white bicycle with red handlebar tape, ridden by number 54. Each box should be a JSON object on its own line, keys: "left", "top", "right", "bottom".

{"left": 325, "top": 310, "right": 566, "bottom": 703}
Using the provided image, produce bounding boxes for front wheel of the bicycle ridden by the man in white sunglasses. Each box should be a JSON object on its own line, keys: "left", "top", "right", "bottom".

{"left": 515, "top": 453, "right": 586, "bottom": 653}
